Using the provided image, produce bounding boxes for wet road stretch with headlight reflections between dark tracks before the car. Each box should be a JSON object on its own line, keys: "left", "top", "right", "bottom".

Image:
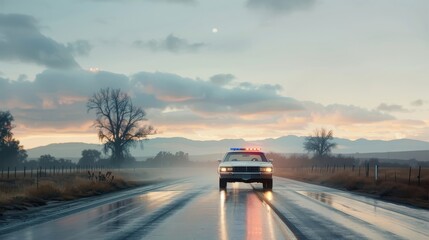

{"left": 146, "top": 184, "right": 290, "bottom": 240}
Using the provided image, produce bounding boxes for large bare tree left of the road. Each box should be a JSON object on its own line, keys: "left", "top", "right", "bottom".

{"left": 87, "top": 88, "right": 156, "bottom": 165}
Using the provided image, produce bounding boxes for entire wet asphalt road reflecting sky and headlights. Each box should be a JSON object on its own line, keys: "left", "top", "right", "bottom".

{"left": 0, "top": 171, "right": 429, "bottom": 240}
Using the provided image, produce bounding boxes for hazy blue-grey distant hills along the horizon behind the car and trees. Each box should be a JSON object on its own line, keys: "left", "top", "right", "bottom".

{"left": 27, "top": 135, "right": 429, "bottom": 161}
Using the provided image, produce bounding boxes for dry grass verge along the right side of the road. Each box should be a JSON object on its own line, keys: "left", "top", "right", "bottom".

{"left": 275, "top": 168, "right": 429, "bottom": 208}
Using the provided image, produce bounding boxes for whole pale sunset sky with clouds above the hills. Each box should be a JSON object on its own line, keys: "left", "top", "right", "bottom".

{"left": 0, "top": 0, "right": 429, "bottom": 148}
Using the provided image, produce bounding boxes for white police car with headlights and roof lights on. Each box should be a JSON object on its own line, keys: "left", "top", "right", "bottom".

{"left": 218, "top": 148, "right": 273, "bottom": 189}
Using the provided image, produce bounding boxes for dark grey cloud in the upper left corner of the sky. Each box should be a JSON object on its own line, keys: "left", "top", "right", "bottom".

{"left": 0, "top": 13, "right": 79, "bottom": 69}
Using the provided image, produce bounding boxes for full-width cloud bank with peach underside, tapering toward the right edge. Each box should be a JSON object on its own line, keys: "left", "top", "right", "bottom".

{"left": 0, "top": 69, "right": 412, "bottom": 144}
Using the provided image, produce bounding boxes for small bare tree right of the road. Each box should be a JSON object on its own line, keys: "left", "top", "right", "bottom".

{"left": 304, "top": 128, "right": 337, "bottom": 158}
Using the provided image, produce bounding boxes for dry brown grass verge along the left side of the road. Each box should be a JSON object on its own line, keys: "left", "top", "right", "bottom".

{"left": 0, "top": 170, "right": 164, "bottom": 216}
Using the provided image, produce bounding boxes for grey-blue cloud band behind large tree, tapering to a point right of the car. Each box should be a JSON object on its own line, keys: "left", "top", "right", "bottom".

{"left": 0, "top": 69, "right": 303, "bottom": 133}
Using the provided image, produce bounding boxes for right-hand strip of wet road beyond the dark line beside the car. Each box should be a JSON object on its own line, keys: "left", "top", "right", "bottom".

{"left": 263, "top": 178, "right": 429, "bottom": 239}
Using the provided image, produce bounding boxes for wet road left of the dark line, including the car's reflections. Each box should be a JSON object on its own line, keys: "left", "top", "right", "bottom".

{"left": 0, "top": 175, "right": 293, "bottom": 240}
